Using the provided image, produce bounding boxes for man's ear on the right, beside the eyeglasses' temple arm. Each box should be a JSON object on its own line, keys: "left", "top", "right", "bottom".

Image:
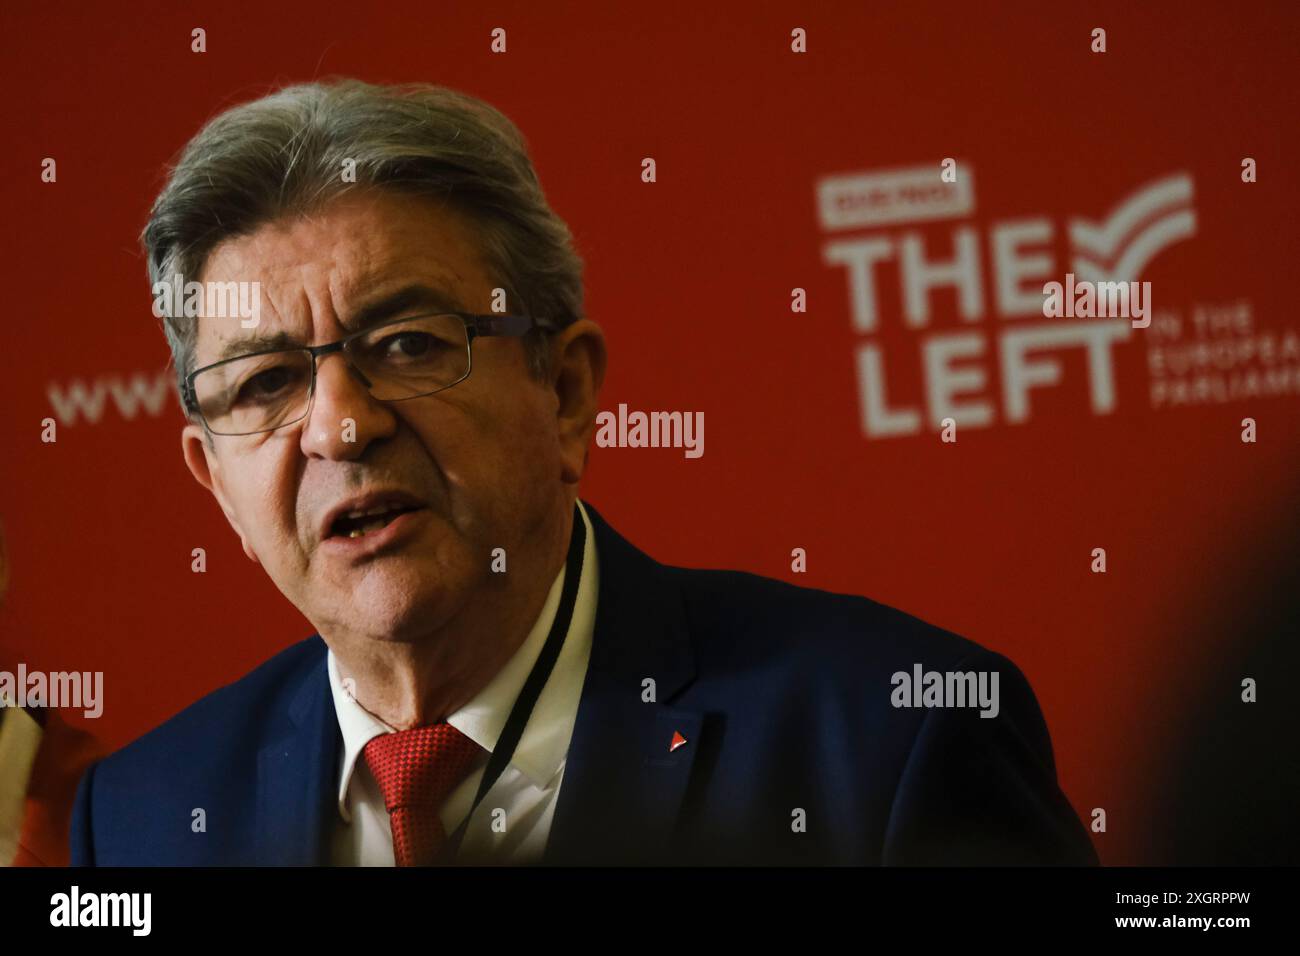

{"left": 551, "top": 319, "right": 607, "bottom": 483}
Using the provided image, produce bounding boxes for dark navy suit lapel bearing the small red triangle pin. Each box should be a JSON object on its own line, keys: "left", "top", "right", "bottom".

{"left": 543, "top": 502, "right": 702, "bottom": 864}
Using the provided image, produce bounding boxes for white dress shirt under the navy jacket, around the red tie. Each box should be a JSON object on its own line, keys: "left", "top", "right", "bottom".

{"left": 328, "top": 501, "right": 599, "bottom": 866}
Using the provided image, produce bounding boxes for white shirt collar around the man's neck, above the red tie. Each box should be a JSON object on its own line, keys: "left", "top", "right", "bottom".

{"left": 326, "top": 501, "right": 599, "bottom": 821}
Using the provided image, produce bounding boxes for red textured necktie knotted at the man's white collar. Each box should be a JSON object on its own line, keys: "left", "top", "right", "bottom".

{"left": 361, "top": 723, "right": 482, "bottom": 866}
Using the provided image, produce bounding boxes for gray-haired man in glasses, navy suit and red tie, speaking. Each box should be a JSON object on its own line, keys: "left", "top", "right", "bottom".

{"left": 72, "top": 82, "right": 1096, "bottom": 865}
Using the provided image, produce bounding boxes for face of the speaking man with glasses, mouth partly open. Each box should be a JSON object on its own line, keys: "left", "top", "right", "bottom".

{"left": 183, "top": 193, "right": 603, "bottom": 640}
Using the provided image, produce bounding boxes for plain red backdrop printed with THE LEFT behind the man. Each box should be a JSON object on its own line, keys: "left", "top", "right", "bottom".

{"left": 0, "top": 0, "right": 1300, "bottom": 864}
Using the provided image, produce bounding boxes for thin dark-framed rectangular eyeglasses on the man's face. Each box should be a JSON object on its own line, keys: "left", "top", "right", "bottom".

{"left": 185, "top": 312, "right": 558, "bottom": 436}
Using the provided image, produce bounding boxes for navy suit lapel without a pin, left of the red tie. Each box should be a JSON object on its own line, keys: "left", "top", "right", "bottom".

{"left": 255, "top": 637, "right": 339, "bottom": 866}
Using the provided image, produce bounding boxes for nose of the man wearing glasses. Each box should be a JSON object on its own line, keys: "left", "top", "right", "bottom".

{"left": 302, "top": 352, "right": 397, "bottom": 459}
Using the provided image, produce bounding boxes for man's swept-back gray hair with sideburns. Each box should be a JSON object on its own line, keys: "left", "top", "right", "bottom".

{"left": 140, "top": 79, "right": 584, "bottom": 414}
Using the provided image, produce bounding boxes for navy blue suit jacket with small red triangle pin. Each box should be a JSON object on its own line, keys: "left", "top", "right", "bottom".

{"left": 72, "top": 502, "right": 1096, "bottom": 865}
